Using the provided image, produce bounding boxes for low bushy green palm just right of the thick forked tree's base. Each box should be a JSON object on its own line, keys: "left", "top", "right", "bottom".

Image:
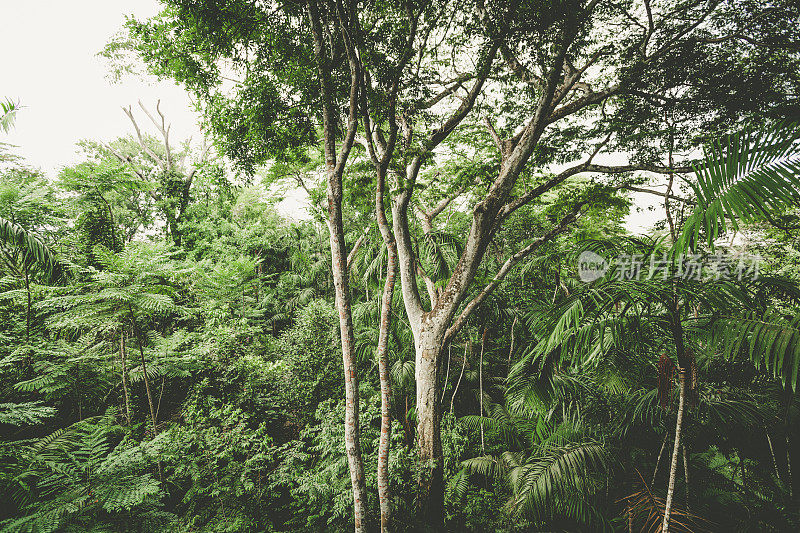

{"left": 450, "top": 375, "right": 613, "bottom": 528}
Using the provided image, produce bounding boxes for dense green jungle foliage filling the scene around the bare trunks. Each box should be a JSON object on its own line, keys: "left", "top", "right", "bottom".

{"left": 0, "top": 0, "right": 800, "bottom": 533}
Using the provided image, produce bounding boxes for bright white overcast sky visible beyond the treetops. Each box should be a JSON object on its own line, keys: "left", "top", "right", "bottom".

{"left": 0, "top": 0, "right": 663, "bottom": 233}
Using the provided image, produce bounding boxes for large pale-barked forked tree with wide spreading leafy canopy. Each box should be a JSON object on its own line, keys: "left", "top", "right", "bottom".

{"left": 114, "top": 0, "right": 798, "bottom": 527}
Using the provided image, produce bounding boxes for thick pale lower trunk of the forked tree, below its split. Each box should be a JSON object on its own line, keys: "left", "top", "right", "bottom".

{"left": 416, "top": 326, "right": 444, "bottom": 531}
